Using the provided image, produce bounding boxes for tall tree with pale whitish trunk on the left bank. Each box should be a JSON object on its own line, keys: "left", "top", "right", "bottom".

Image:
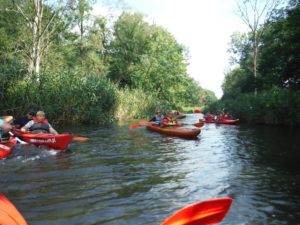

{"left": 0, "top": 0, "right": 67, "bottom": 81}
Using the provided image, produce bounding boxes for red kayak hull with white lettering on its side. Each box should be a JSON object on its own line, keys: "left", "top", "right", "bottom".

{"left": 13, "top": 130, "right": 73, "bottom": 150}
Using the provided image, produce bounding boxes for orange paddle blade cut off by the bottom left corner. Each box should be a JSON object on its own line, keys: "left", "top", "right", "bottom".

{"left": 0, "top": 193, "right": 27, "bottom": 225}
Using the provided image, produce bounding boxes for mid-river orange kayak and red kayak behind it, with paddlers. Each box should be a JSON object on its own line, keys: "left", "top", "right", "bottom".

{"left": 129, "top": 110, "right": 239, "bottom": 138}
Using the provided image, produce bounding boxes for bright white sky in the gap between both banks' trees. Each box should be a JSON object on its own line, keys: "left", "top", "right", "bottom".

{"left": 94, "top": 0, "right": 247, "bottom": 98}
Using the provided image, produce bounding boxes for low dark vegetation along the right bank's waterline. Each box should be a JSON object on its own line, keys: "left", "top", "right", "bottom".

{"left": 207, "top": 88, "right": 300, "bottom": 126}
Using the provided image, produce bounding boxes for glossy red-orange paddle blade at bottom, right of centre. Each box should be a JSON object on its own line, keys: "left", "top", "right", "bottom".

{"left": 161, "top": 198, "right": 232, "bottom": 225}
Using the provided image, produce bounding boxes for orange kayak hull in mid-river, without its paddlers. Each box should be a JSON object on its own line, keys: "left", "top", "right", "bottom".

{"left": 146, "top": 124, "right": 201, "bottom": 138}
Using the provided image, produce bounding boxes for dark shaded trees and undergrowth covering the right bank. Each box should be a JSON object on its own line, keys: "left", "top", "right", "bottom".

{"left": 208, "top": 1, "right": 300, "bottom": 125}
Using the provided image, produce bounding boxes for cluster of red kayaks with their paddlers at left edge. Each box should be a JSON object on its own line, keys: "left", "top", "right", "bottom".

{"left": 0, "top": 111, "right": 82, "bottom": 159}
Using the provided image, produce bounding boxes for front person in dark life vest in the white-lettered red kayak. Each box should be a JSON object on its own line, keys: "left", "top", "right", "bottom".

{"left": 21, "top": 111, "right": 58, "bottom": 135}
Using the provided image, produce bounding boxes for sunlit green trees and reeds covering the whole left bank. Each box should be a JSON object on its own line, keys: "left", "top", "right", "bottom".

{"left": 0, "top": 0, "right": 216, "bottom": 123}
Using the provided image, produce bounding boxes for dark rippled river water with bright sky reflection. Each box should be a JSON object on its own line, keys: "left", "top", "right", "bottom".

{"left": 0, "top": 114, "right": 300, "bottom": 225}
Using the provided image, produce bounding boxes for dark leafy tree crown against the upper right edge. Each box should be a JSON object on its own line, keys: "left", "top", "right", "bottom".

{"left": 259, "top": 3, "right": 300, "bottom": 88}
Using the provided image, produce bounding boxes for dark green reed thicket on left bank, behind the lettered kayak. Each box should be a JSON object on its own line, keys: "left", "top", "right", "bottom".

{"left": 7, "top": 71, "right": 117, "bottom": 123}
